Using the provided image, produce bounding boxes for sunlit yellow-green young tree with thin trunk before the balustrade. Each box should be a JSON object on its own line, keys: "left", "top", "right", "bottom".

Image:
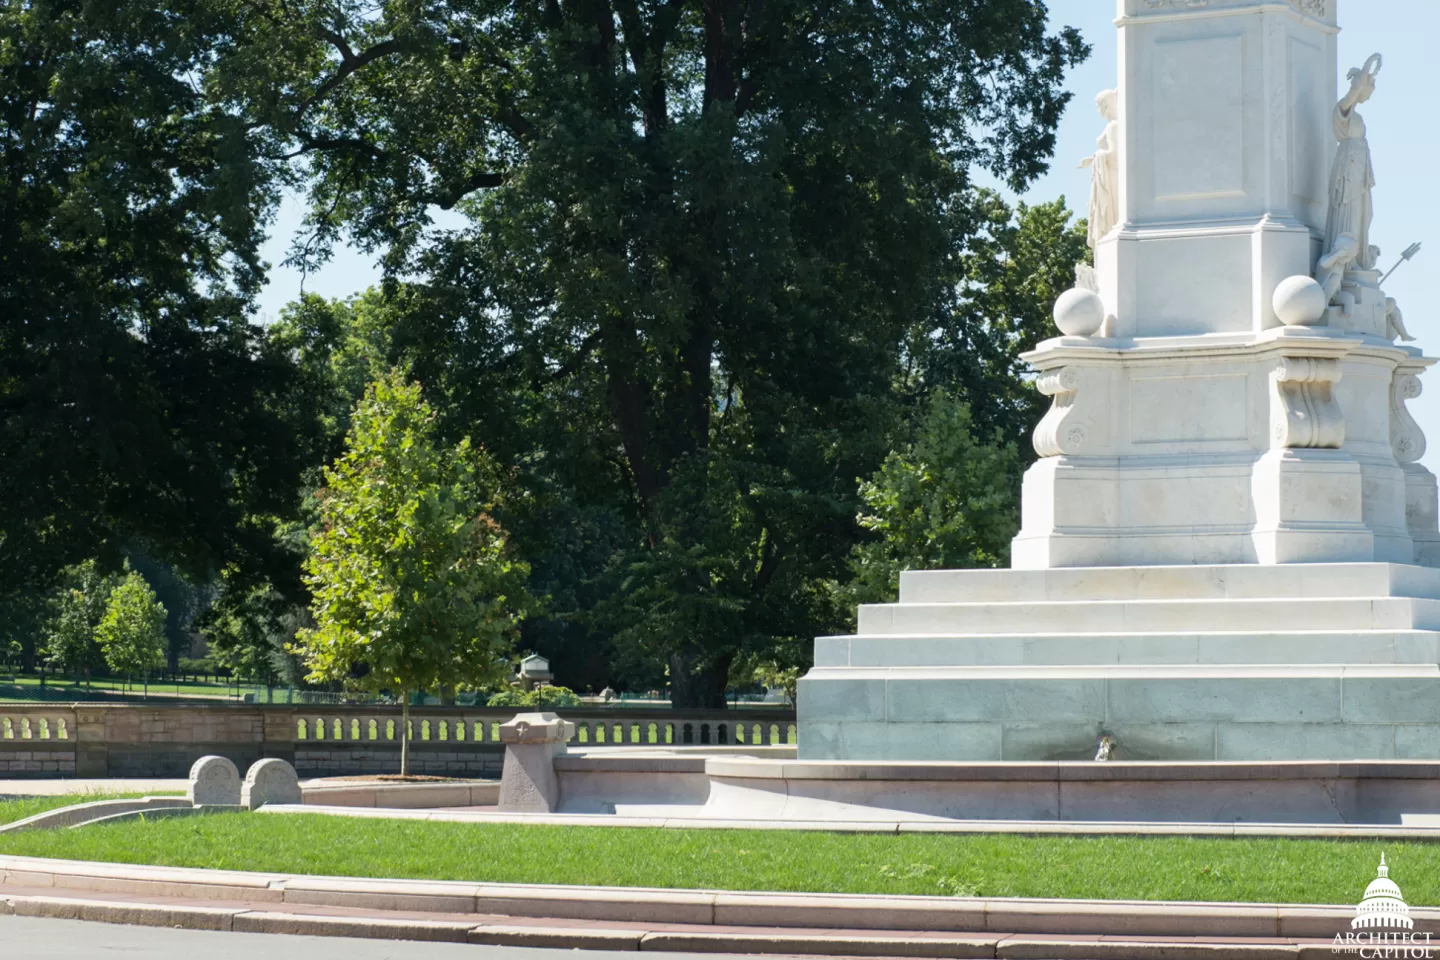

{"left": 295, "top": 370, "right": 528, "bottom": 776}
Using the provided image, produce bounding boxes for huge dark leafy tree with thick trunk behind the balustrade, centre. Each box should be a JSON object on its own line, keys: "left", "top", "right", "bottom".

{"left": 225, "top": 0, "right": 1086, "bottom": 707}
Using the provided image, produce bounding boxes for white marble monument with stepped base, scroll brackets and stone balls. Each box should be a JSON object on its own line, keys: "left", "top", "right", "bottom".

{"left": 799, "top": 0, "right": 1440, "bottom": 760}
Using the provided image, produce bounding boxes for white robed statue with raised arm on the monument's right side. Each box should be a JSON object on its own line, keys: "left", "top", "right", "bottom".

{"left": 1325, "top": 53, "right": 1384, "bottom": 271}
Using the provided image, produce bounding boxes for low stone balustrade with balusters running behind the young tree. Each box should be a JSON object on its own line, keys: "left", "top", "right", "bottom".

{"left": 0, "top": 704, "right": 796, "bottom": 779}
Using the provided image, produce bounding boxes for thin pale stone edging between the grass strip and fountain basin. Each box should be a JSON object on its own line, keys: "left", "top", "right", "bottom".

{"left": 256, "top": 802, "right": 1440, "bottom": 841}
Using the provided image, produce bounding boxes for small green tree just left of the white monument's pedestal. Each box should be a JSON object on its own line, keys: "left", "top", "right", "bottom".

{"left": 847, "top": 391, "right": 1024, "bottom": 603}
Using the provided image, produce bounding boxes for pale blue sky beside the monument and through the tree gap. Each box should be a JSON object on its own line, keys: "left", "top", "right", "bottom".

{"left": 261, "top": 0, "right": 1440, "bottom": 472}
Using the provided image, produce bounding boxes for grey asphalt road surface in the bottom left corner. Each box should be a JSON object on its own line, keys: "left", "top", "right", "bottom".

{"left": 0, "top": 917, "right": 766, "bottom": 960}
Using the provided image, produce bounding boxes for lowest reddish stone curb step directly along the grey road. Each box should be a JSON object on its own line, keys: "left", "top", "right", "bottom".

{"left": 0, "top": 895, "right": 1332, "bottom": 960}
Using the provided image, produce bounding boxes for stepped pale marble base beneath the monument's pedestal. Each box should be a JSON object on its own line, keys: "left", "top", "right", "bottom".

{"left": 799, "top": 563, "right": 1440, "bottom": 761}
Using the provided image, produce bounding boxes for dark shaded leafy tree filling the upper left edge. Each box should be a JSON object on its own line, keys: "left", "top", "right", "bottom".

{"left": 0, "top": 0, "right": 321, "bottom": 589}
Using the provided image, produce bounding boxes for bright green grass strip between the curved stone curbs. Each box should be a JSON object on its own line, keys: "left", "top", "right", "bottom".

{"left": 0, "top": 813, "right": 1422, "bottom": 905}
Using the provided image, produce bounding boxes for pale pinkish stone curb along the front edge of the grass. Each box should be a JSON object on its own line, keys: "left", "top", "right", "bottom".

{"left": 0, "top": 856, "right": 1416, "bottom": 940}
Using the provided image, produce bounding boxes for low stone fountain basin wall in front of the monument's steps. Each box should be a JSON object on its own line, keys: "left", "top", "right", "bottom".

{"left": 554, "top": 751, "right": 1440, "bottom": 826}
